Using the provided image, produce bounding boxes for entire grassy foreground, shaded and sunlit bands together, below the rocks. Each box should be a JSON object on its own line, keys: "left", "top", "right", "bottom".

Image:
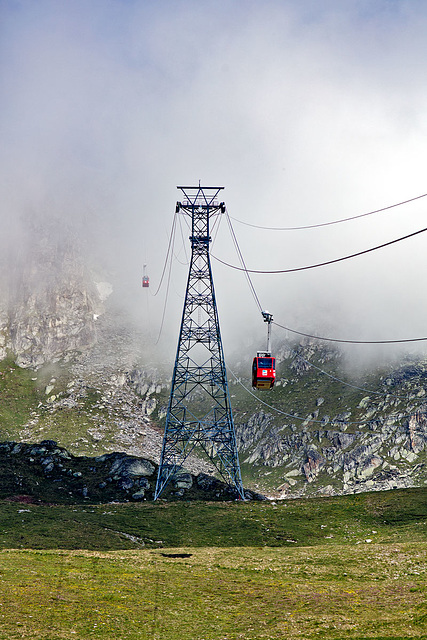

{"left": 0, "top": 489, "right": 427, "bottom": 640}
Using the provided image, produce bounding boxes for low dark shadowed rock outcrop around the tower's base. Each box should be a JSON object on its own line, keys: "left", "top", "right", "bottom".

{"left": 0, "top": 440, "right": 264, "bottom": 503}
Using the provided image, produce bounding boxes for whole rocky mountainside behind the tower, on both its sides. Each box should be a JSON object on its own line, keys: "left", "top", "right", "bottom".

{"left": 0, "top": 225, "right": 427, "bottom": 497}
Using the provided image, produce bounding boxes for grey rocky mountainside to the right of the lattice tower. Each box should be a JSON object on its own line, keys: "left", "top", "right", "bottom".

{"left": 237, "top": 342, "right": 427, "bottom": 497}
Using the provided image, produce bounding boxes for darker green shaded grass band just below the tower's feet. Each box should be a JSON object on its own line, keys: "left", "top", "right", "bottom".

{"left": 0, "top": 489, "right": 427, "bottom": 551}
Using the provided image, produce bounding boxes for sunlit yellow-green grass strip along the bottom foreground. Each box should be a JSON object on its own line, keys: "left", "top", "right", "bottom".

{"left": 0, "top": 543, "right": 427, "bottom": 640}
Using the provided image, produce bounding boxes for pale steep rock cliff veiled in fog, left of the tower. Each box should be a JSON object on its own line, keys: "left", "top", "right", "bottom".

{"left": 0, "top": 220, "right": 102, "bottom": 369}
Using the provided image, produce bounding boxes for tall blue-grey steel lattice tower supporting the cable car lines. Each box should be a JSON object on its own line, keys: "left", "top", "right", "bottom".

{"left": 154, "top": 183, "right": 244, "bottom": 500}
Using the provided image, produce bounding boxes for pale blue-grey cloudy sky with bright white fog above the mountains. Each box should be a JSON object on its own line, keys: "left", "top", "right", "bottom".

{"left": 0, "top": 0, "right": 427, "bottom": 360}
